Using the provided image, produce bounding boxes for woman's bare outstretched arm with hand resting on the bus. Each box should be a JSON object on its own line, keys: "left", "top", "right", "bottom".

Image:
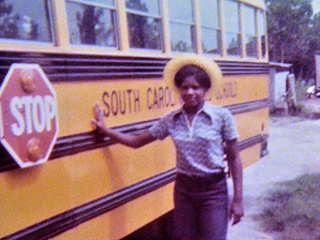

{"left": 91, "top": 104, "right": 156, "bottom": 148}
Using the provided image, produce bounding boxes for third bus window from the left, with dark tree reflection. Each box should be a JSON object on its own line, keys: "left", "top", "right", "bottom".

{"left": 126, "top": 0, "right": 163, "bottom": 50}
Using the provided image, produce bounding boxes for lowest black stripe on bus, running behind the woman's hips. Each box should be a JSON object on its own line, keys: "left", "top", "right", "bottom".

{"left": 0, "top": 134, "right": 264, "bottom": 240}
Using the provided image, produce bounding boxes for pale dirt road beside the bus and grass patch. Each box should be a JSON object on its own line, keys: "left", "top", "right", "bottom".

{"left": 228, "top": 117, "right": 320, "bottom": 240}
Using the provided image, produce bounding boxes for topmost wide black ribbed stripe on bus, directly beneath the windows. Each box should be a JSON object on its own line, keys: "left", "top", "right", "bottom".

{"left": 0, "top": 52, "right": 269, "bottom": 81}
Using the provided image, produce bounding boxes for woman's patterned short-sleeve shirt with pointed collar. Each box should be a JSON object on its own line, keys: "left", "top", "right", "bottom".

{"left": 149, "top": 102, "right": 239, "bottom": 176}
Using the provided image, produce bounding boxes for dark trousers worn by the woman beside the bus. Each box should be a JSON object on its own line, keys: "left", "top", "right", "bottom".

{"left": 174, "top": 173, "right": 229, "bottom": 240}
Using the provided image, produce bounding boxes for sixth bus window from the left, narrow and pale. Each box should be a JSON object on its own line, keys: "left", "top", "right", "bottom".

{"left": 224, "top": 0, "right": 241, "bottom": 56}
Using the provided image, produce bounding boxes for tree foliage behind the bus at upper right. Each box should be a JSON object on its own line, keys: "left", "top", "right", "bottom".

{"left": 266, "top": 0, "right": 320, "bottom": 78}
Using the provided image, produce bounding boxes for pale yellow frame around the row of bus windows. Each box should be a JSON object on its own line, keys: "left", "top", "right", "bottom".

{"left": 0, "top": 0, "right": 268, "bottom": 62}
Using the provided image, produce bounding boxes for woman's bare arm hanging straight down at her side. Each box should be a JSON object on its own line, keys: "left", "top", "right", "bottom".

{"left": 226, "top": 139, "right": 244, "bottom": 225}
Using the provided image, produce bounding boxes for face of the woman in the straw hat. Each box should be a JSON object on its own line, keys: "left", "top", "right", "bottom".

{"left": 179, "top": 76, "right": 207, "bottom": 108}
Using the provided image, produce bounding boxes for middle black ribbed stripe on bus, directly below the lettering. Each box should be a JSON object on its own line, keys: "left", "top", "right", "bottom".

{"left": 0, "top": 99, "right": 269, "bottom": 173}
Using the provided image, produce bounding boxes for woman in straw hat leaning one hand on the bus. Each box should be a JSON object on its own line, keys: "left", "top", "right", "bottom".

{"left": 92, "top": 55, "right": 244, "bottom": 240}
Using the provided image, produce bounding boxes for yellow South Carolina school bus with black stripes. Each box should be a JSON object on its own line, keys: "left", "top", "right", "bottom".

{"left": 0, "top": 0, "right": 269, "bottom": 240}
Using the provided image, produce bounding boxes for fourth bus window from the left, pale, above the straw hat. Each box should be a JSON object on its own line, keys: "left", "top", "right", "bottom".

{"left": 168, "top": 0, "right": 195, "bottom": 52}
